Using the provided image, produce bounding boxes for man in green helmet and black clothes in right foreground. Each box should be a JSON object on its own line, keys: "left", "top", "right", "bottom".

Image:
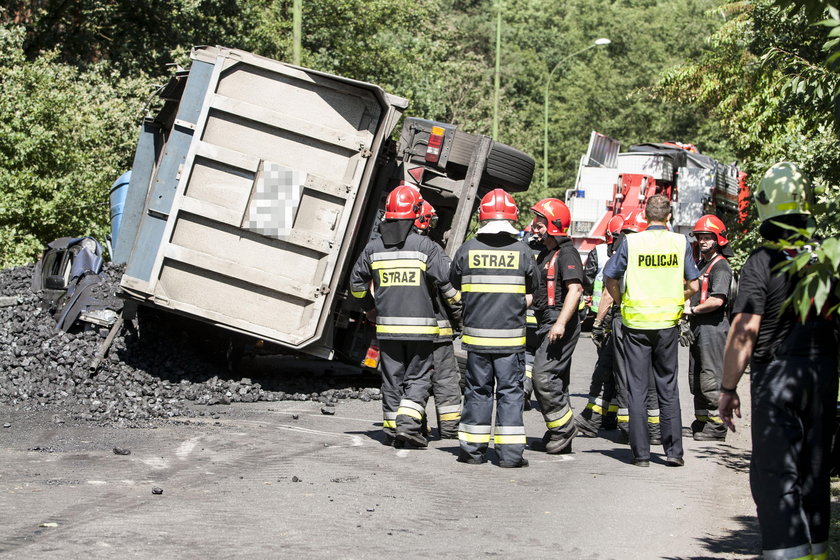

{"left": 718, "top": 162, "right": 838, "bottom": 559}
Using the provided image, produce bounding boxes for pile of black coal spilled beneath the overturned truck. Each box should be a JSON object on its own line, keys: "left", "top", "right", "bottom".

{"left": 0, "top": 265, "right": 380, "bottom": 426}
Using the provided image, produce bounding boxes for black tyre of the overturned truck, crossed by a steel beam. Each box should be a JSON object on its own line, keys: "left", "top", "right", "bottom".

{"left": 447, "top": 130, "right": 535, "bottom": 192}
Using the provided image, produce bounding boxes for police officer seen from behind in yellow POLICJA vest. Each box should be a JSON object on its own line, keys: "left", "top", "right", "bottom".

{"left": 604, "top": 195, "right": 700, "bottom": 467}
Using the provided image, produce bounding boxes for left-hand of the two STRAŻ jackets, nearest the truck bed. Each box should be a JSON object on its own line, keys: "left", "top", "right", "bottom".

{"left": 350, "top": 228, "right": 459, "bottom": 340}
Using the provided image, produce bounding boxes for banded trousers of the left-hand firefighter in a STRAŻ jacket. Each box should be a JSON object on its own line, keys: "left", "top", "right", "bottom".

{"left": 379, "top": 340, "right": 434, "bottom": 437}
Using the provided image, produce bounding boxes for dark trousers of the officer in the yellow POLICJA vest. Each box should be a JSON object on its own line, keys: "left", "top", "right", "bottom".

{"left": 622, "top": 326, "right": 683, "bottom": 459}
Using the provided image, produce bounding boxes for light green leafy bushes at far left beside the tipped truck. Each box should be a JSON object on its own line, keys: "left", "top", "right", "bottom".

{"left": 0, "top": 27, "right": 148, "bottom": 267}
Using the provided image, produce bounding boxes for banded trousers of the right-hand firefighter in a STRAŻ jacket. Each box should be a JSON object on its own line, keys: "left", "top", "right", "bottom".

{"left": 458, "top": 352, "right": 525, "bottom": 465}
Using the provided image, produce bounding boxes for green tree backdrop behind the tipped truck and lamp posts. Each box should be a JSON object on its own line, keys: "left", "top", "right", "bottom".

{"left": 0, "top": 0, "right": 732, "bottom": 264}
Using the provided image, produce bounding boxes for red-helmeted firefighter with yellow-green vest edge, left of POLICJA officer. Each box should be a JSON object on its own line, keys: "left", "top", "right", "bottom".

{"left": 575, "top": 214, "right": 624, "bottom": 437}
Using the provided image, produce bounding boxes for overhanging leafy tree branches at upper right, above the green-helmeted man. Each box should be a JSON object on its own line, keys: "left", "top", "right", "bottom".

{"left": 655, "top": 0, "right": 840, "bottom": 280}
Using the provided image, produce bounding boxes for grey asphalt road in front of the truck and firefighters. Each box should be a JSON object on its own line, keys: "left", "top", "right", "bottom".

{"left": 0, "top": 338, "right": 759, "bottom": 559}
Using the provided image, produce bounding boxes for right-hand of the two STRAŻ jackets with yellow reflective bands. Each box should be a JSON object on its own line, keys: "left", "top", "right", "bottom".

{"left": 449, "top": 233, "right": 540, "bottom": 354}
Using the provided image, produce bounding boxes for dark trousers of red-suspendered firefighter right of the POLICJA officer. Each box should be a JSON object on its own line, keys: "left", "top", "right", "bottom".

{"left": 688, "top": 320, "right": 729, "bottom": 437}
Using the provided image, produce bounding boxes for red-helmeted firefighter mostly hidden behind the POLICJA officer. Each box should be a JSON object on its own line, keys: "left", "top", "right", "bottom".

{"left": 602, "top": 208, "right": 662, "bottom": 445}
